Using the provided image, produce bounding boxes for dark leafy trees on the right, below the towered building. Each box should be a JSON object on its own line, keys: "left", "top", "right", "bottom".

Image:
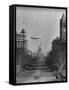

{"left": 46, "top": 48, "right": 66, "bottom": 80}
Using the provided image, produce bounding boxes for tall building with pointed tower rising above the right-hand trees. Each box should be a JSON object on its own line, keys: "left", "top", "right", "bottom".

{"left": 52, "top": 14, "right": 66, "bottom": 50}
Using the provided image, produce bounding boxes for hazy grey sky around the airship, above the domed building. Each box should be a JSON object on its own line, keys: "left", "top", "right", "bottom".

{"left": 16, "top": 7, "right": 65, "bottom": 54}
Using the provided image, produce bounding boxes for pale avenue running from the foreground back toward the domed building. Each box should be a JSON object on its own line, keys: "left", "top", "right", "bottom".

{"left": 16, "top": 56, "right": 56, "bottom": 83}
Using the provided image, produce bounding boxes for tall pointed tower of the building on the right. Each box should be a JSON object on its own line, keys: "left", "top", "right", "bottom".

{"left": 60, "top": 14, "right": 66, "bottom": 41}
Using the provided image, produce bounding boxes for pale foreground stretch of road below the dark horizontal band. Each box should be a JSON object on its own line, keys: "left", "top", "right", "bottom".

{"left": 16, "top": 70, "right": 56, "bottom": 83}
